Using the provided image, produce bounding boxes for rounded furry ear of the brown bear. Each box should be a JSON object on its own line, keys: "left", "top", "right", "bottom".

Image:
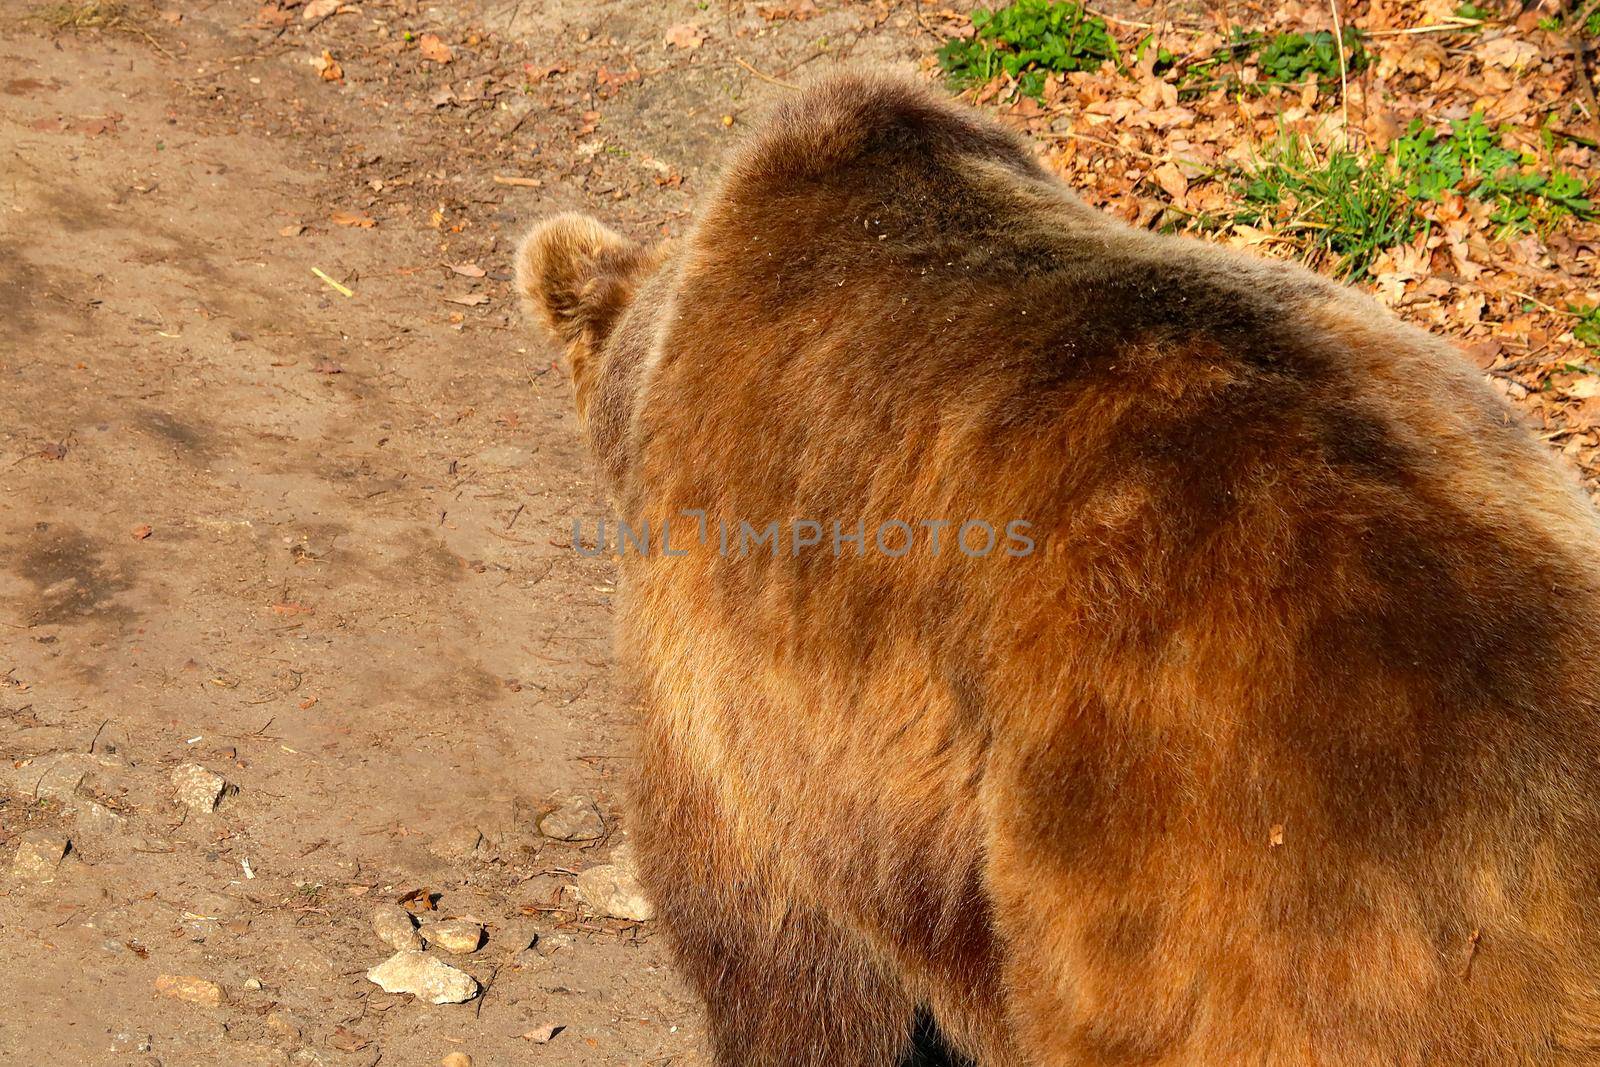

{"left": 517, "top": 213, "right": 638, "bottom": 346}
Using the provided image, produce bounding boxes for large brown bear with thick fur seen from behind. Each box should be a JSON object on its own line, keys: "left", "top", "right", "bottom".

{"left": 522, "top": 77, "right": 1600, "bottom": 1067}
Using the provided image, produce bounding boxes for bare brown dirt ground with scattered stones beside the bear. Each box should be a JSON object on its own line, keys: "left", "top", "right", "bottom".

{"left": 0, "top": 0, "right": 931, "bottom": 1065}
